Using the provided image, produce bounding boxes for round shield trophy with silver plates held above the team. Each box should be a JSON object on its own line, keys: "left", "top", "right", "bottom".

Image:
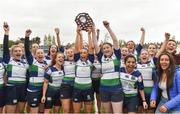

{"left": 75, "top": 13, "right": 93, "bottom": 31}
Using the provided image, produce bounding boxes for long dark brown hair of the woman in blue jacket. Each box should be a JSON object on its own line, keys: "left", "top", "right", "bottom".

{"left": 157, "top": 52, "right": 175, "bottom": 88}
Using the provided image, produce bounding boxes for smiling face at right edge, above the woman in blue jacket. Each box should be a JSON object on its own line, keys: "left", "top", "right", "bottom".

{"left": 166, "top": 40, "right": 177, "bottom": 53}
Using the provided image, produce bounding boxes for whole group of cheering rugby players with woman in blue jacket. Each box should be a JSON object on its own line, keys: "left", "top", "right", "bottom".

{"left": 0, "top": 21, "right": 180, "bottom": 113}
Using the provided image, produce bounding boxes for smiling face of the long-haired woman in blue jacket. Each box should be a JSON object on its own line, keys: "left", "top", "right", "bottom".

{"left": 159, "top": 55, "right": 170, "bottom": 71}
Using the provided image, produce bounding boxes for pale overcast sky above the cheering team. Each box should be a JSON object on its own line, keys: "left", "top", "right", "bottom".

{"left": 0, "top": 0, "right": 180, "bottom": 43}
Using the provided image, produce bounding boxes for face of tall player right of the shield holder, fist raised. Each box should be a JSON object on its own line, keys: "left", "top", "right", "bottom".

{"left": 103, "top": 44, "right": 113, "bottom": 57}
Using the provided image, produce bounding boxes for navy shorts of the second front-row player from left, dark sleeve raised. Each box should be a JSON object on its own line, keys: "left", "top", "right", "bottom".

{"left": 27, "top": 91, "right": 42, "bottom": 107}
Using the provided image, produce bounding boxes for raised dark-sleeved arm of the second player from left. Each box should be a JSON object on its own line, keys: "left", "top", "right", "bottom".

{"left": 24, "top": 29, "right": 33, "bottom": 65}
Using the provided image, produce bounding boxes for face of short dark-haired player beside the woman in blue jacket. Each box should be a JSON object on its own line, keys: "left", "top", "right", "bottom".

{"left": 125, "top": 57, "right": 136, "bottom": 73}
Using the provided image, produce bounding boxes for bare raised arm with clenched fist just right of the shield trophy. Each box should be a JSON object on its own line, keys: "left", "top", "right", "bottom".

{"left": 103, "top": 21, "right": 119, "bottom": 49}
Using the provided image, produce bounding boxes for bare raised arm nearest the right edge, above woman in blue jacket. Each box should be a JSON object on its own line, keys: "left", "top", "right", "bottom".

{"left": 155, "top": 33, "right": 170, "bottom": 58}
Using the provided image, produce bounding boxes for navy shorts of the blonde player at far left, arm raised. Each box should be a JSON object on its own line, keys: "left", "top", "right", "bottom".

{"left": 5, "top": 84, "right": 27, "bottom": 105}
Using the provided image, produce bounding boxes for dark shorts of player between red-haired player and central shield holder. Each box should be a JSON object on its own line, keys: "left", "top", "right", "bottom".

{"left": 60, "top": 84, "right": 73, "bottom": 99}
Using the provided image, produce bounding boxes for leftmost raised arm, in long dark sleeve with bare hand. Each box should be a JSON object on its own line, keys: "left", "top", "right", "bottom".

{"left": 3, "top": 22, "right": 10, "bottom": 63}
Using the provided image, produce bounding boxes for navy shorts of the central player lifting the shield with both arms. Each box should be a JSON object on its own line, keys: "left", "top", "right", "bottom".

{"left": 73, "top": 88, "right": 94, "bottom": 102}
